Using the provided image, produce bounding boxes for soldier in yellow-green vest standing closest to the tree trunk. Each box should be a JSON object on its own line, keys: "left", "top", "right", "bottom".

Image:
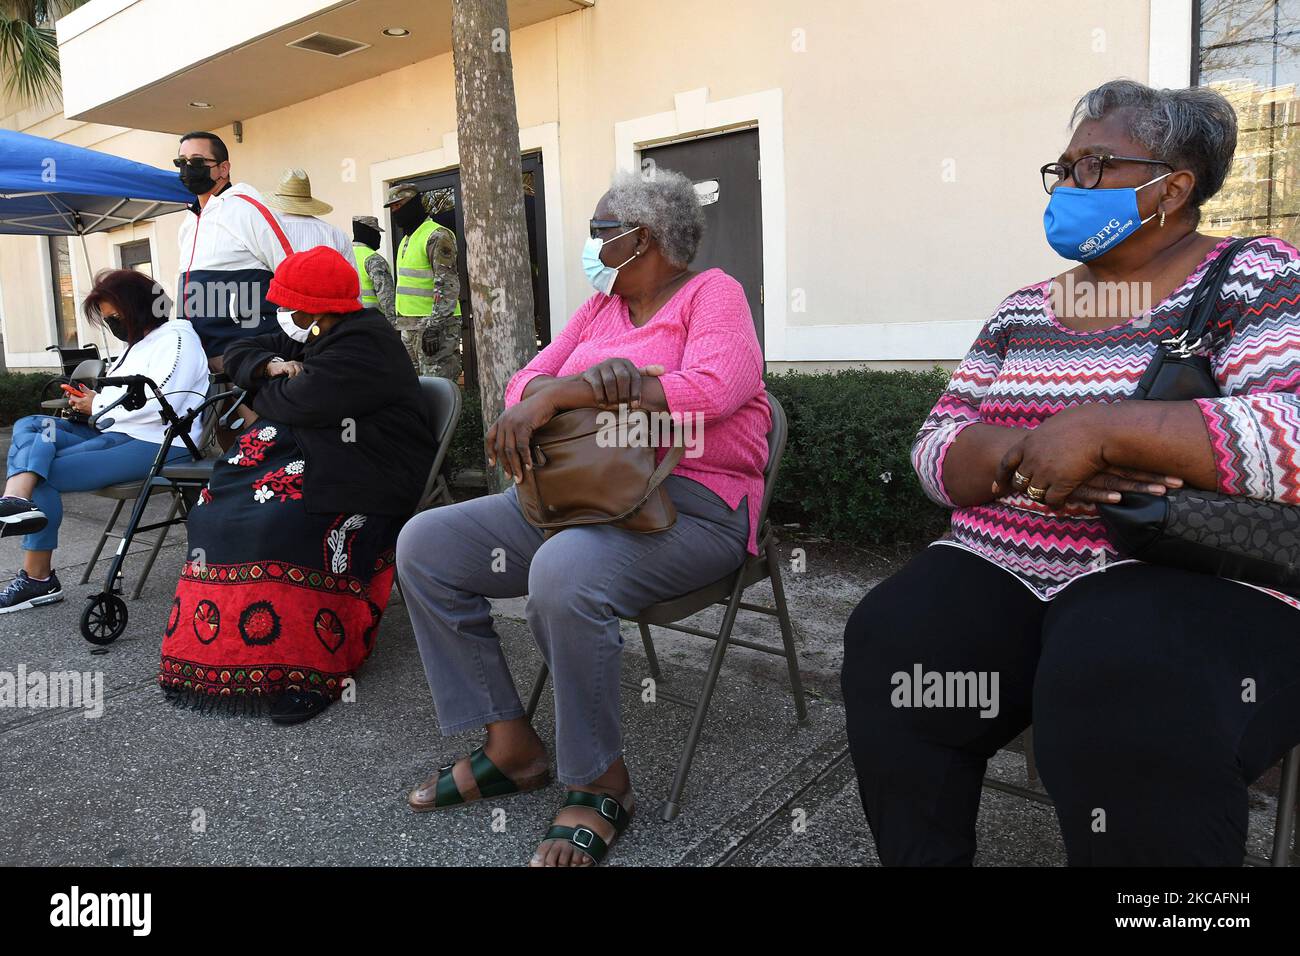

{"left": 385, "top": 182, "right": 462, "bottom": 381}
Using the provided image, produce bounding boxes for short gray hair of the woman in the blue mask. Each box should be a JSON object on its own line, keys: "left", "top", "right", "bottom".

{"left": 1070, "top": 79, "right": 1236, "bottom": 220}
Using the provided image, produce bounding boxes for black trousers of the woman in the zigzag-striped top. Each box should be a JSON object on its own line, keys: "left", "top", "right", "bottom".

{"left": 841, "top": 546, "right": 1300, "bottom": 866}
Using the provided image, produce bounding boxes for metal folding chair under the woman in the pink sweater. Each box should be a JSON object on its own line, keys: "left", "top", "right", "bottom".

{"left": 528, "top": 393, "right": 807, "bottom": 821}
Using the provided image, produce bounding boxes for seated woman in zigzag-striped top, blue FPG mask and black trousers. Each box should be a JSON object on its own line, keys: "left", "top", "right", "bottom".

{"left": 842, "top": 81, "right": 1300, "bottom": 865}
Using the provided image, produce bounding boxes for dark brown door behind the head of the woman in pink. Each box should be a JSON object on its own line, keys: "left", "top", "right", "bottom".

{"left": 641, "top": 129, "right": 763, "bottom": 345}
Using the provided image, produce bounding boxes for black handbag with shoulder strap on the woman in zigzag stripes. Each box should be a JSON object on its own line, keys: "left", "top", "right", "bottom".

{"left": 1097, "top": 238, "right": 1300, "bottom": 597}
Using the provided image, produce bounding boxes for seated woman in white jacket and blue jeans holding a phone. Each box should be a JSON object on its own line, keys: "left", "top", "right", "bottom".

{"left": 0, "top": 269, "right": 208, "bottom": 614}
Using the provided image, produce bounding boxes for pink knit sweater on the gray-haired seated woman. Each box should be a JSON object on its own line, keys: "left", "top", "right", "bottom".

{"left": 506, "top": 269, "right": 772, "bottom": 554}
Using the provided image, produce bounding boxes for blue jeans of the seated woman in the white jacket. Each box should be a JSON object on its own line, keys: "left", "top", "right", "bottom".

{"left": 7, "top": 415, "right": 190, "bottom": 551}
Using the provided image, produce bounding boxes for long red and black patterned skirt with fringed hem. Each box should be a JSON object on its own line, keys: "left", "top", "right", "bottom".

{"left": 159, "top": 419, "right": 402, "bottom": 710}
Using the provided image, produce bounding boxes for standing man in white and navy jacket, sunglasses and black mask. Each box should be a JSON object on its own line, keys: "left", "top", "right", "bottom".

{"left": 176, "top": 133, "right": 294, "bottom": 372}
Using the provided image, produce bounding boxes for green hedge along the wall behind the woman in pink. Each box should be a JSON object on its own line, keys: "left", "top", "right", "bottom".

{"left": 449, "top": 368, "right": 948, "bottom": 548}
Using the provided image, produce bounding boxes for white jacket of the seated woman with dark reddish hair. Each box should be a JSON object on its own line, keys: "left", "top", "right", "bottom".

{"left": 91, "top": 319, "right": 208, "bottom": 445}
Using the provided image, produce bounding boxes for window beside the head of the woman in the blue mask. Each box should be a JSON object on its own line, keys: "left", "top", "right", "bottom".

{"left": 1193, "top": 0, "right": 1300, "bottom": 245}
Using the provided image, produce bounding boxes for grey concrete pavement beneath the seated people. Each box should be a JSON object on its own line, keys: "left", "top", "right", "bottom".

{"left": 0, "top": 481, "right": 1273, "bottom": 866}
